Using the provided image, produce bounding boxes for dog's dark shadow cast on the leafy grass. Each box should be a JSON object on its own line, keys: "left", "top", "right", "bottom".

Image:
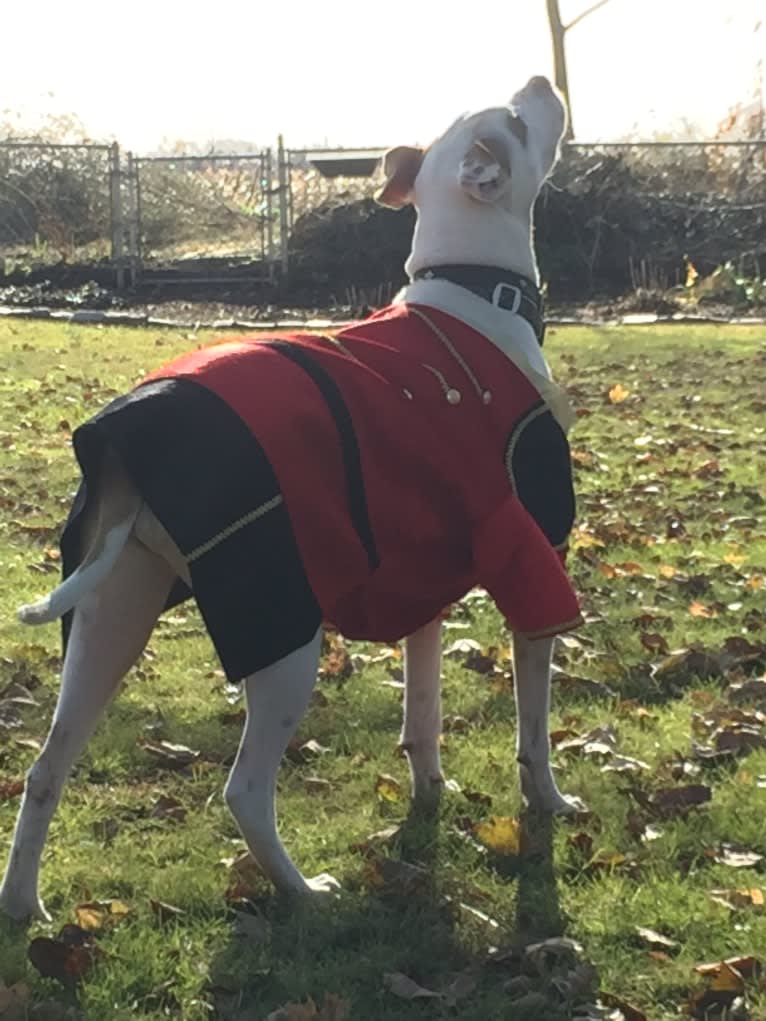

{"left": 210, "top": 809, "right": 564, "bottom": 1021}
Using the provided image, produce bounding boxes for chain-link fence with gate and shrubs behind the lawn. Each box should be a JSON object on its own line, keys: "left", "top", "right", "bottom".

{"left": 0, "top": 139, "right": 766, "bottom": 294}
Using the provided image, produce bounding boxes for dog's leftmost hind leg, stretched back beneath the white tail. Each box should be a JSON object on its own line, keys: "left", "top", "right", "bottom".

{"left": 0, "top": 538, "right": 174, "bottom": 919}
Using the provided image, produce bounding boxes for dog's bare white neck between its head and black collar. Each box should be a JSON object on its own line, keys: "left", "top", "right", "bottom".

{"left": 404, "top": 202, "right": 539, "bottom": 284}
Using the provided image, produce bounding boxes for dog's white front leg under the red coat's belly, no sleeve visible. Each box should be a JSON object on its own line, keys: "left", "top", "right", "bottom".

{"left": 400, "top": 620, "right": 444, "bottom": 806}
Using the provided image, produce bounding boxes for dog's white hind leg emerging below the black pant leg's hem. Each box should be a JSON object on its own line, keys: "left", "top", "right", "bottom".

{"left": 225, "top": 628, "right": 337, "bottom": 893}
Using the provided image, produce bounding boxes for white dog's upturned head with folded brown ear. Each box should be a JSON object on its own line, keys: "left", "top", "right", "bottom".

{"left": 376, "top": 77, "right": 566, "bottom": 214}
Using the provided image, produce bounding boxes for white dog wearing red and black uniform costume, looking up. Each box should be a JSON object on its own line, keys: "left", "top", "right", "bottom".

{"left": 0, "top": 78, "right": 580, "bottom": 919}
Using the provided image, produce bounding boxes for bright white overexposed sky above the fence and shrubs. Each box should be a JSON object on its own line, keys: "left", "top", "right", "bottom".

{"left": 0, "top": 0, "right": 766, "bottom": 152}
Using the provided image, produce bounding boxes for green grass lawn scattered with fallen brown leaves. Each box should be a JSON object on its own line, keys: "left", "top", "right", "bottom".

{"left": 0, "top": 320, "right": 766, "bottom": 1021}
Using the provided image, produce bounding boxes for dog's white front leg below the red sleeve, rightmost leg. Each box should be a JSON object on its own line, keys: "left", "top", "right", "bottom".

{"left": 514, "top": 634, "right": 585, "bottom": 815}
